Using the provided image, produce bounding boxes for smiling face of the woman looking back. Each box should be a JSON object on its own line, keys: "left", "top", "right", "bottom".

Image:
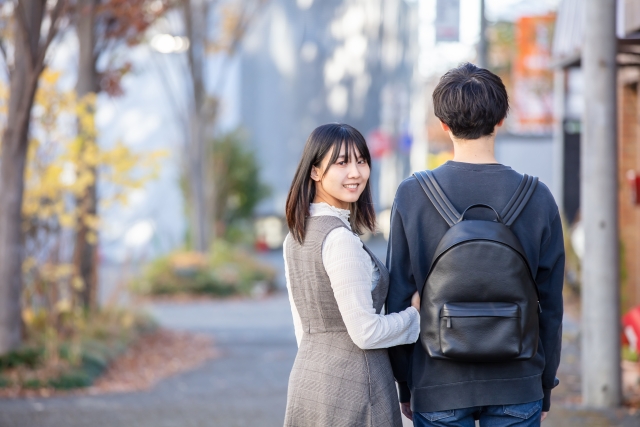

{"left": 311, "top": 144, "right": 371, "bottom": 209}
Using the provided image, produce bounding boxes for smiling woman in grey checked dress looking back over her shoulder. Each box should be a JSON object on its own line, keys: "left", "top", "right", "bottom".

{"left": 284, "top": 124, "right": 420, "bottom": 427}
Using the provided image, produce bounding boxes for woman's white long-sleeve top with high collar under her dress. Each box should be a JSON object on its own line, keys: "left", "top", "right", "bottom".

{"left": 283, "top": 203, "right": 420, "bottom": 350}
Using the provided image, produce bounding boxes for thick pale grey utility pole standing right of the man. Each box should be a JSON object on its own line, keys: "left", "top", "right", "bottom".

{"left": 580, "top": 0, "right": 622, "bottom": 408}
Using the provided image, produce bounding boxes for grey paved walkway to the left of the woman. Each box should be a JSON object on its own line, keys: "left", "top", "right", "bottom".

{"left": 0, "top": 295, "right": 296, "bottom": 427}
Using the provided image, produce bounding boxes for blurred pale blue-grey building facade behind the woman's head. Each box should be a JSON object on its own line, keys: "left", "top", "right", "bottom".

{"left": 240, "top": 0, "right": 418, "bottom": 217}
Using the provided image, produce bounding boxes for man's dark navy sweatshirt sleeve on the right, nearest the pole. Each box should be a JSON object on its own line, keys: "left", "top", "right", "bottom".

{"left": 536, "top": 213, "right": 565, "bottom": 411}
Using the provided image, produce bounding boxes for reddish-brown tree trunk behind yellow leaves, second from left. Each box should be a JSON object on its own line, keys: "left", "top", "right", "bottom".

{"left": 73, "top": 0, "right": 99, "bottom": 309}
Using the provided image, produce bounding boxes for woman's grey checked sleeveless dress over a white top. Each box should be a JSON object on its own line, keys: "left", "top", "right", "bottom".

{"left": 284, "top": 216, "right": 402, "bottom": 427}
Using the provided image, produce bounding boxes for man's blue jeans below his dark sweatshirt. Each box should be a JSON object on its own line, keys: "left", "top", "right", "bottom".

{"left": 413, "top": 400, "right": 542, "bottom": 427}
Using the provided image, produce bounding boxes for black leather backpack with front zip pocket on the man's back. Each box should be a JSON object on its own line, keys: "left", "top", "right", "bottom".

{"left": 414, "top": 171, "right": 540, "bottom": 362}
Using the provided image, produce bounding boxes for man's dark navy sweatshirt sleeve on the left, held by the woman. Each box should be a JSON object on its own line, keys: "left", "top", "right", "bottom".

{"left": 387, "top": 204, "right": 417, "bottom": 403}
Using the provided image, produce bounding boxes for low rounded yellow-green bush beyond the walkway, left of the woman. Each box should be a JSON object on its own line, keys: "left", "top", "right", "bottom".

{"left": 131, "top": 240, "right": 275, "bottom": 297}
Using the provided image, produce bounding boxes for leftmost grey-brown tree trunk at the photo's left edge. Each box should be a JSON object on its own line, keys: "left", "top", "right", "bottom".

{"left": 0, "top": 0, "right": 45, "bottom": 354}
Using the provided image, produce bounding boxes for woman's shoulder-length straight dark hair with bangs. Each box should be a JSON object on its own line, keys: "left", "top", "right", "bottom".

{"left": 286, "top": 123, "right": 376, "bottom": 243}
